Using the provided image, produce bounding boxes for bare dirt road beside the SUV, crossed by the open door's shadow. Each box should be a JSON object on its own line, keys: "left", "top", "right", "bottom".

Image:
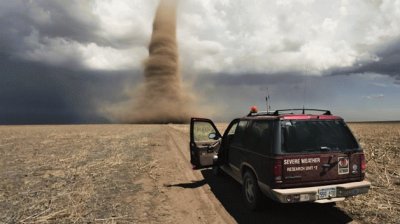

{"left": 142, "top": 126, "right": 234, "bottom": 223}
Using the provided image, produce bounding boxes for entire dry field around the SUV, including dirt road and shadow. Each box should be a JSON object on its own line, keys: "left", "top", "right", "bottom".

{"left": 0, "top": 123, "right": 400, "bottom": 223}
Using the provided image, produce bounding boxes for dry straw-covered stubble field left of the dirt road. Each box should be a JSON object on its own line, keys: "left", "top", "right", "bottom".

{"left": 0, "top": 125, "right": 162, "bottom": 223}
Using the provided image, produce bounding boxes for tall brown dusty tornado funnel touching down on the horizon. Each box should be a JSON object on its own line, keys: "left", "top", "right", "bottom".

{"left": 128, "top": 0, "right": 190, "bottom": 123}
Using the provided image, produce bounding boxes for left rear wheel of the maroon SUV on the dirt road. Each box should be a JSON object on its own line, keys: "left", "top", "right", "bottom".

{"left": 243, "top": 171, "right": 263, "bottom": 211}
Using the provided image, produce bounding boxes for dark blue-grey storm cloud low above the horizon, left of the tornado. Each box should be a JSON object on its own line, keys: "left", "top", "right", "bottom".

{"left": 0, "top": 54, "right": 141, "bottom": 124}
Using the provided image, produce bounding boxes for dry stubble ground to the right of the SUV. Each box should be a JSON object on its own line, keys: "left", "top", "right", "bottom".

{"left": 338, "top": 123, "right": 400, "bottom": 223}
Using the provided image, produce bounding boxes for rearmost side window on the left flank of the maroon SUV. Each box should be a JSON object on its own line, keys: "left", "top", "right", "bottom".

{"left": 245, "top": 120, "right": 273, "bottom": 155}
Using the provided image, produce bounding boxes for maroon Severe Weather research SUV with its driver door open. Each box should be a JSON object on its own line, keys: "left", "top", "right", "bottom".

{"left": 190, "top": 109, "right": 370, "bottom": 210}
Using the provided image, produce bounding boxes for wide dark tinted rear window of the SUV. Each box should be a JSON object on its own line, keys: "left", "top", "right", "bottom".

{"left": 282, "top": 120, "right": 359, "bottom": 152}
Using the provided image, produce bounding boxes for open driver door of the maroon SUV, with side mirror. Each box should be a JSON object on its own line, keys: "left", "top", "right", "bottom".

{"left": 189, "top": 118, "right": 221, "bottom": 169}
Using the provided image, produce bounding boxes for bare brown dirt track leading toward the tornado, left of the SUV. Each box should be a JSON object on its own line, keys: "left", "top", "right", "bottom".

{"left": 139, "top": 125, "right": 234, "bottom": 223}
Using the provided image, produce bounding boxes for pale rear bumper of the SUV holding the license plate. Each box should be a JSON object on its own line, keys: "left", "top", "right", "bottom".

{"left": 268, "top": 181, "right": 371, "bottom": 203}
